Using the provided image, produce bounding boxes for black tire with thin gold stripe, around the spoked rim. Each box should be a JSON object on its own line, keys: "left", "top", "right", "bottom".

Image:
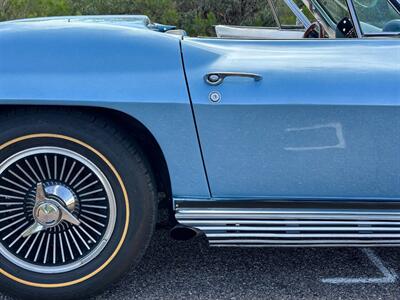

{"left": 0, "top": 108, "right": 157, "bottom": 299}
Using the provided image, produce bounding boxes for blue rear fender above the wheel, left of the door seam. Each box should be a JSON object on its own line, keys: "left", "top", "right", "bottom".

{"left": 0, "top": 20, "right": 210, "bottom": 197}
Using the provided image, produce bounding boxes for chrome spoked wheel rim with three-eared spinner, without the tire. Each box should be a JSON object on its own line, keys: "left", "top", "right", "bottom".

{"left": 0, "top": 147, "right": 116, "bottom": 274}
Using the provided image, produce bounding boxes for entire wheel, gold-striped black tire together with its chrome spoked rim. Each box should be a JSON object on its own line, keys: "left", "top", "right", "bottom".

{"left": 0, "top": 112, "right": 158, "bottom": 300}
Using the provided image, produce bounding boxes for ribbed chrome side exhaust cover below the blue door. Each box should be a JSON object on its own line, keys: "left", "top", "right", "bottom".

{"left": 175, "top": 202, "right": 400, "bottom": 247}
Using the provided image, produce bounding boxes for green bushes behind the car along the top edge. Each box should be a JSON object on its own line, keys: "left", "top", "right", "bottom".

{"left": 0, "top": 0, "right": 310, "bottom": 36}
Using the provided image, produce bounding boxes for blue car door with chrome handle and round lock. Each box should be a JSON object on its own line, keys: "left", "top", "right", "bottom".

{"left": 182, "top": 38, "right": 400, "bottom": 200}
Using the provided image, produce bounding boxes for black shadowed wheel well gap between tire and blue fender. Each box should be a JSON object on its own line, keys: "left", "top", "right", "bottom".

{"left": 0, "top": 105, "right": 172, "bottom": 208}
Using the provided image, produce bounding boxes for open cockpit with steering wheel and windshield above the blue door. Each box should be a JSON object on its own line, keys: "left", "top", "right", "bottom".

{"left": 211, "top": 0, "right": 400, "bottom": 39}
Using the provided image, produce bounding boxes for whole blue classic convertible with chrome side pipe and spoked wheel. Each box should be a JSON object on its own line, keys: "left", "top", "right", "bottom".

{"left": 0, "top": 0, "right": 400, "bottom": 299}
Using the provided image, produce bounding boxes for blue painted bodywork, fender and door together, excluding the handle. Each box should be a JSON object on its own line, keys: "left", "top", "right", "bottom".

{"left": 0, "top": 17, "right": 400, "bottom": 201}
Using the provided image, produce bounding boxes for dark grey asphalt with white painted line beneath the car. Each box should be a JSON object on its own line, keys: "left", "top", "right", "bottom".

{"left": 0, "top": 229, "right": 400, "bottom": 300}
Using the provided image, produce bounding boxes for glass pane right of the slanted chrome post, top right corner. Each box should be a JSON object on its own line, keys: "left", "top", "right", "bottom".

{"left": 354, "top": 0, "right": 400, "bottom": 34}
